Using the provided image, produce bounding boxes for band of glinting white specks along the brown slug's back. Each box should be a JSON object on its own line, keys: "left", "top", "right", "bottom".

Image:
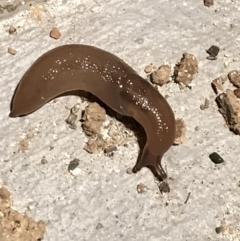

{"left": 42, "top": 52, "right": 168, "bottom": 134}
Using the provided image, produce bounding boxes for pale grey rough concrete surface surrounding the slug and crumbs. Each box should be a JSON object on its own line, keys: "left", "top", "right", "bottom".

{"left": 0, "top": 0, "right": 240, "bottom": 241}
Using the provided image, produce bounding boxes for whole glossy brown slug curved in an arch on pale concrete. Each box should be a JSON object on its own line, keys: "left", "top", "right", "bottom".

{"left": 9, "top": 44, "right": 175, "bottom": 181}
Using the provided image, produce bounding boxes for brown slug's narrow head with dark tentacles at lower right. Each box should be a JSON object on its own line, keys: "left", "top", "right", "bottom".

{"left": 133, "top": 146, "right": 167, "bottom": 181}
